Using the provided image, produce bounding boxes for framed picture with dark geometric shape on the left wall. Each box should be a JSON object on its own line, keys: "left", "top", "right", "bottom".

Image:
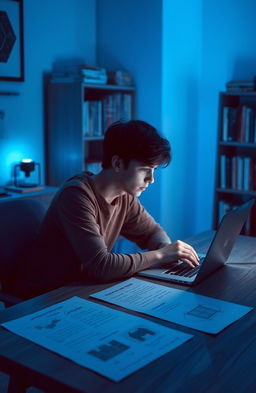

{"left": 0, "top": 0, "right": 24, "bottom": 82}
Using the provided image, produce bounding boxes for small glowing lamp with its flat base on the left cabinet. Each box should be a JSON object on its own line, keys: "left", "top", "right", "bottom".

{"left": 5, "top": 158, "right": 44, "bottom": 193}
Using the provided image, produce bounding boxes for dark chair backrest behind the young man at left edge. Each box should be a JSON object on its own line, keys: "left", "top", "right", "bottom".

{"left": 0, "top": 198, "right": 46, "bottom": 282}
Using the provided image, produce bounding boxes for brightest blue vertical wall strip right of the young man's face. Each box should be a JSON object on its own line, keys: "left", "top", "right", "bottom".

{"left": 161, "top": 0, "right": 202, "bottom": 239}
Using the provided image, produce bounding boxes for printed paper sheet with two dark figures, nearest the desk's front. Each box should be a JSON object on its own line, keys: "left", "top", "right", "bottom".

{"left": 2, "top": 297, "right": 192, "bottom": 382}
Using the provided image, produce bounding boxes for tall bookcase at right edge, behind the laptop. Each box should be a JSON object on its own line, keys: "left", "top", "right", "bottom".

{"left": 213, "top": 91, "right": 256, "bottom": 236}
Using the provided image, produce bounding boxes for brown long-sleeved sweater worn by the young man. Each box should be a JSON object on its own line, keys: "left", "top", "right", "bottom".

{"left": 13, "top": 172, "right": 170, "bottom": 295}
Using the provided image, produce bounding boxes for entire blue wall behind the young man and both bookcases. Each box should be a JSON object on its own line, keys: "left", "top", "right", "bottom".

{"left": 0, "top": 0, "right": 256, "bottom": 239}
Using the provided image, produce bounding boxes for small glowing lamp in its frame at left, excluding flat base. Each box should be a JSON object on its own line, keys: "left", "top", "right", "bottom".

{"left": 14, "top": 158, "right": 41, "bottom": 190}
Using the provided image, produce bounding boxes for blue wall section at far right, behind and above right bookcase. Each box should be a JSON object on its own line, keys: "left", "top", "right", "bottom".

{"left": 195, "top": 0, "right": 256, "bottom": 232}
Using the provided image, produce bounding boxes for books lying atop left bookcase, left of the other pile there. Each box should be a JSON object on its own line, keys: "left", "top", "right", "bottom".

{"left": 51, "top": 64, "right": 108, "bottom": 84}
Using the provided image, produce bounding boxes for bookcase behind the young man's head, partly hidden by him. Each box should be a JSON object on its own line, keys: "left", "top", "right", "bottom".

{"left": 46, "top": 80, "right": 135, "bottom": 186}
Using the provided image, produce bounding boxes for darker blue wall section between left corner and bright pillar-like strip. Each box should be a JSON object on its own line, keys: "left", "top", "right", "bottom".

{"left": 98, "top": 0, "right": 162, "bottom": 220}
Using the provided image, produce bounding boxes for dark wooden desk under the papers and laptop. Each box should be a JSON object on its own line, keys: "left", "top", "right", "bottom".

{"left": 0, "top": 232, "right": 256, "bottom": 393}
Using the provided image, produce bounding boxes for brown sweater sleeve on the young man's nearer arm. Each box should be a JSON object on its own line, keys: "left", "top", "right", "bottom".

{"left": 57, "top": 187, "right": 158, "bottom": 282}
